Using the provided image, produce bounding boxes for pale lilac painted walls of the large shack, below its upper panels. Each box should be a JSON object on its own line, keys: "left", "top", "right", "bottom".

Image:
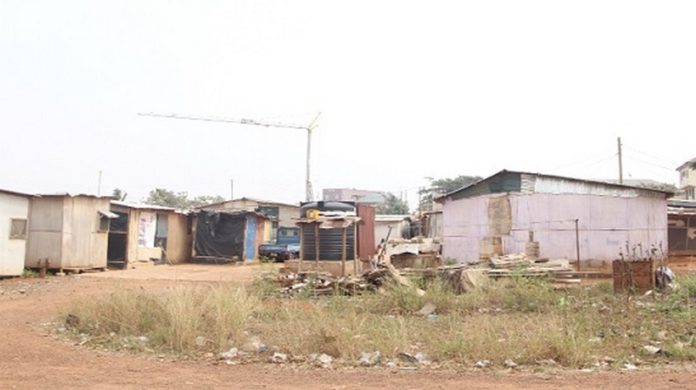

{"left": 443, "top": 193, "right": 667, "bottom": 262}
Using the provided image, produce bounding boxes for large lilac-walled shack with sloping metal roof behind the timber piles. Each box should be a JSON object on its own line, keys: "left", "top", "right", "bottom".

{"left": 438, "top": 170, "right": 671, "bottom": 267}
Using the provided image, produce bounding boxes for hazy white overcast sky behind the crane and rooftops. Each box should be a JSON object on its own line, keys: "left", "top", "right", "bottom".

{"left": 0, "top": 0, "right": 696, "bottom": 210}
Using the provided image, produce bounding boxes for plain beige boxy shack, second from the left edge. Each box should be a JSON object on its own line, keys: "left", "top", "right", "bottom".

{"left": 25, "top": 194, "right": 116, "bottom": 270}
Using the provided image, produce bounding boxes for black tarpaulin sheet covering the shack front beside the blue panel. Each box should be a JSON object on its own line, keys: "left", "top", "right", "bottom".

{"left": 194, "top": 211, "right": 248, "bottom": 260}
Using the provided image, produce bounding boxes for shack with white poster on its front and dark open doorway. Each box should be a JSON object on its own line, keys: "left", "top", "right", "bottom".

{"left": 108, "top": 201, "right": 193, "bottom": 268}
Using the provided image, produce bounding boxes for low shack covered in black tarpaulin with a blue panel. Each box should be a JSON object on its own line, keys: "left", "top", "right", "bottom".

{"left": 193, "top": 210, "right": 271, "bottom": 262}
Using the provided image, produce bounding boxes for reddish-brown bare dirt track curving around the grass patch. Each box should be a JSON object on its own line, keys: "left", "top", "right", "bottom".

{"left": 0, "top": 265, "right": 696, "bottom": 390}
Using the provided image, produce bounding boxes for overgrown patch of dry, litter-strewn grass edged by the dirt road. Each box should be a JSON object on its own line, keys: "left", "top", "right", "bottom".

{"left": 65, "top": 277, "right": 696, "bottom": 368}
